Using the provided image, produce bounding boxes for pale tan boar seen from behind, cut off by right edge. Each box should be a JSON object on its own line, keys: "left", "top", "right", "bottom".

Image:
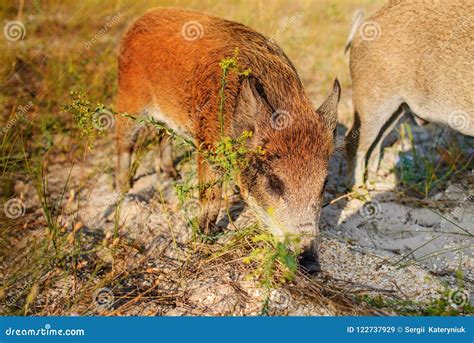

{"left": 346, "top": 0, "right": 474, "bottom": 187}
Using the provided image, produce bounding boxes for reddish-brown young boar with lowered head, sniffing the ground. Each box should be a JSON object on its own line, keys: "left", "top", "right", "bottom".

{"left": 117, "top": 8, "right": 340, "bottom": 268}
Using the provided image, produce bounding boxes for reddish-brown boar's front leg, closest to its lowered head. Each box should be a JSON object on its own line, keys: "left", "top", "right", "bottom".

{"left": 198, "top": 156, "right": 222, "bottom": 236}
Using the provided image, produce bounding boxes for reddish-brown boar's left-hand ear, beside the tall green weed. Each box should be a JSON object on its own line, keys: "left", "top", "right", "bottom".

{"left": 232, "top": 77, "right": 271, "bottom": 136}
